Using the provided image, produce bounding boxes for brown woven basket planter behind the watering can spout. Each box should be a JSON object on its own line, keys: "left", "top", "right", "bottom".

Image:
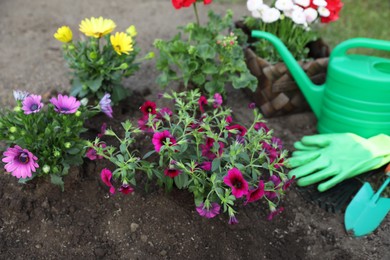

{"left": 244, "top": 48, "right": 329, "bottom": 117}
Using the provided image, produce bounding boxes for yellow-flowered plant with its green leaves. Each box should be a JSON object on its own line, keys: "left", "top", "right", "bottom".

{"left": 54, "top": 17, "right": 153, "bottom": 104}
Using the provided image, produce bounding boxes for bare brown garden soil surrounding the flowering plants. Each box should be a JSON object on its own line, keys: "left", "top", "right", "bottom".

{"left": 0, "top": 0, "right": 390, "bottom": 259}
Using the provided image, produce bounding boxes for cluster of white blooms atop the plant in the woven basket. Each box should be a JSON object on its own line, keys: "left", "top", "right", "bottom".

{"left": 247, "top": 0, "right": 330, "bottom": 27}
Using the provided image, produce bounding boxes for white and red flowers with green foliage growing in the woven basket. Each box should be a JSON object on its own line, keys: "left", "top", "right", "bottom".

{"left": 244, "top": 0, "right": 343, "bottom": 62}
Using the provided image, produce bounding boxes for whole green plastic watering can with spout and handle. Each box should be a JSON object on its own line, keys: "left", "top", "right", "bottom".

{"left": 252, "top": 31, "right": 390, "bottom": 138}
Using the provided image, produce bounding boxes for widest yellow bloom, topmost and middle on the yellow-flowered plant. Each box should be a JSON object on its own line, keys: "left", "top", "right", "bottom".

{"left": 80, "top": 16, "right": 116, "bottom": 38}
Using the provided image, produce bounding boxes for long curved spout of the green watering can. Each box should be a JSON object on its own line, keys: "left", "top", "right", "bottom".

{"left": 252, "top": 30, "right": 324, "bottom": 118}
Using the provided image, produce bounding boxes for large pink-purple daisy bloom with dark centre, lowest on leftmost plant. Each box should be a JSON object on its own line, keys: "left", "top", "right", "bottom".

{"left": 2, "top": 145, "right": 39, "bottom": 179}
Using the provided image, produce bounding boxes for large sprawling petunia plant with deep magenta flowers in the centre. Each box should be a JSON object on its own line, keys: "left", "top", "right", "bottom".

{"left": 90, "top": 90, "right": 292, "bottom": 224}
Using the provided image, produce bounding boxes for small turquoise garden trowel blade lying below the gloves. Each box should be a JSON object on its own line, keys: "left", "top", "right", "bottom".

{"left": 344, "top": 164, "right": 390, "bottom": 236}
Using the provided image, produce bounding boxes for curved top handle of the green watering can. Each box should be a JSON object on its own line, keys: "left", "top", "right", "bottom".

{"left": 331, "top": 38, "right": 390, "bottom": 57}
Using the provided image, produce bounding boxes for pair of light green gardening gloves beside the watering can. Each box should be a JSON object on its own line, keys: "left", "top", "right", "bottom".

{"left": 289, "top": 133, "right": 390, "bottom": 192}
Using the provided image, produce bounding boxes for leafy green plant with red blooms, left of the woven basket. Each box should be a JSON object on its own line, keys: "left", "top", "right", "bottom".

{"left": 154, "top": 0, "right": 257, "bottom": 95}
